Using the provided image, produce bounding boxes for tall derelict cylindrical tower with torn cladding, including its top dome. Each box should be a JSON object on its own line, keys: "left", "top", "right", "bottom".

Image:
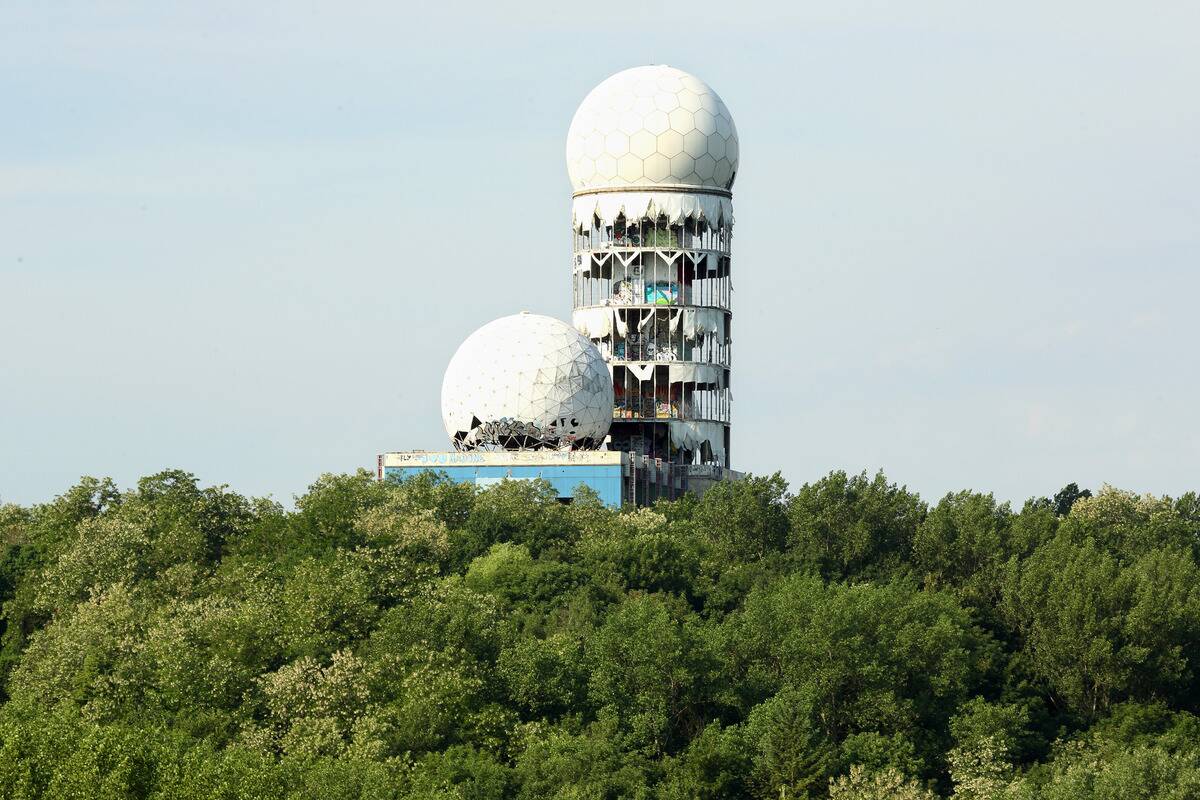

{"left": 566, "top": 65, "right": 738, "bottom": 477}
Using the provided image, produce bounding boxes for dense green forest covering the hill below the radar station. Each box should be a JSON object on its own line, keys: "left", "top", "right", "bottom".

{"left": 0, "top": 470, "right": 1200, "bottom": 800}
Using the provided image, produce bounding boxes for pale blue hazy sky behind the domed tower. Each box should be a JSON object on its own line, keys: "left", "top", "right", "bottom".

{"left": 0, "top": 0, "right": 1200, "bottom": 505}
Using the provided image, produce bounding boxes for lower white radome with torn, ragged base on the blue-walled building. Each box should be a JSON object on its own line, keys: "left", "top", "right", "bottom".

{"left": 442, "top": 313, "right": 612, "bottom": 450}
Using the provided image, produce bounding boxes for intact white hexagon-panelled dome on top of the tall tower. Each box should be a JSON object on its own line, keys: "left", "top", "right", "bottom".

{"left": 566, "top": 65, "right": 738, "bottom": 192}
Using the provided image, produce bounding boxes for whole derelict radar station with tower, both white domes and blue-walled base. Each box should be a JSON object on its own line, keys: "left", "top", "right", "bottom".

{"left": 377, "top": 66, "right": 740, "bottom": 509}
